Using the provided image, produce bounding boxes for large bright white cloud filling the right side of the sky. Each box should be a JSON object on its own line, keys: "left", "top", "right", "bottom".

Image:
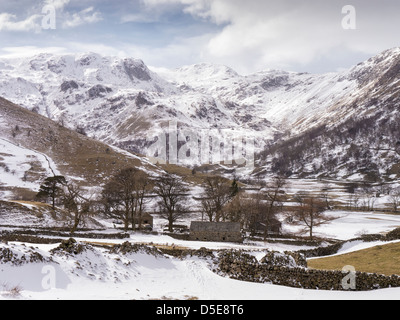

{"left": 138, "top": 0, "right": 400, "bottom": 73}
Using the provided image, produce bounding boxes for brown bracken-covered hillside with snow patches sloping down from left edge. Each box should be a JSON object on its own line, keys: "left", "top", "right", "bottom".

{"left": 0, "top": 98, "right": 162, "bottom": 199}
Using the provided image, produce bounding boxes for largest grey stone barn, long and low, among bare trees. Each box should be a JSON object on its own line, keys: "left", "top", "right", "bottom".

{"left": 189, "top": 221, "right": 243, "bottom": 242}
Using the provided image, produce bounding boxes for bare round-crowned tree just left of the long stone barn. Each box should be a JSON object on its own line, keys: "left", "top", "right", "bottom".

{"left": 154, "top": 173, "right": 189, "bottom": 232}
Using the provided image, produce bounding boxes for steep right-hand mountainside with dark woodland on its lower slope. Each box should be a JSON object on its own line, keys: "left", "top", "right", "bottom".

{"left": 259, "top": 49, "right": 400, "bottom": 182}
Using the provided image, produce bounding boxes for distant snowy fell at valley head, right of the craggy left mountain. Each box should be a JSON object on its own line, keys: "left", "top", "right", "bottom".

{"left": 161, "top": 64, "right": 357, "bottom": 133}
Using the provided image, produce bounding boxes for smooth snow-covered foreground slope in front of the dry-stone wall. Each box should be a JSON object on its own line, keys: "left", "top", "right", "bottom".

{"left": 0, "top": 238, "right": 400, "bottom": 300}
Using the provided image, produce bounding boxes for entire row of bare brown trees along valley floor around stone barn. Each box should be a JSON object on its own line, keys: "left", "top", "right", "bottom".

{"left": 37, "top": 168, "right": 340, "bottom": 237}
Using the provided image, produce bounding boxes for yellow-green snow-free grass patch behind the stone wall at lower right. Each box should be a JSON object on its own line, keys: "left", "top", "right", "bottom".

{"left": 308, "top": 243, "right": 400, "bottom": 276}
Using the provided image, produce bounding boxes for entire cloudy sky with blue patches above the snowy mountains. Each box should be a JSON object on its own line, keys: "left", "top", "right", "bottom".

{"left": 0, "top": 0, "right": 400, "bottom": 74}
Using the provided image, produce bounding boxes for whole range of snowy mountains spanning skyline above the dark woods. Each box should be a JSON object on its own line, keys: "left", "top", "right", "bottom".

{"left": 0, "top": 48, "right": 400, "bottom": 178}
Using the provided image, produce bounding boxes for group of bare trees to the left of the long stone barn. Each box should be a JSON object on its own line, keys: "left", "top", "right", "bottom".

{"left": 37, "top": 168, "right": 188, "bottom": 233}
